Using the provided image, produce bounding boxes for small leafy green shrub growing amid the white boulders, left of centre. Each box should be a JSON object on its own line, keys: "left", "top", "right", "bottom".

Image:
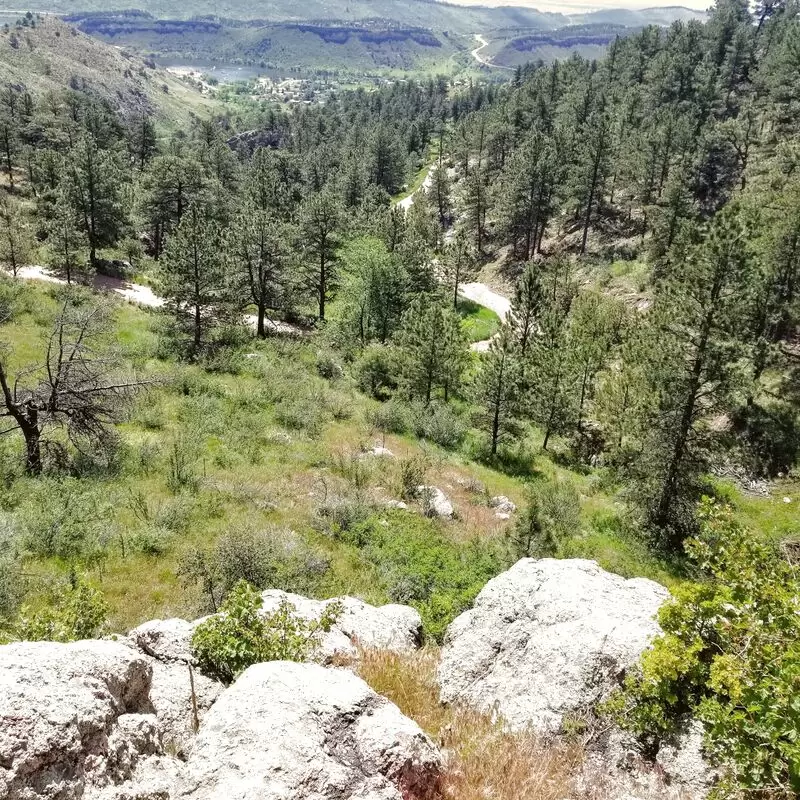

{"left": 192, "top": 580, "right": 341, "bottom": 683}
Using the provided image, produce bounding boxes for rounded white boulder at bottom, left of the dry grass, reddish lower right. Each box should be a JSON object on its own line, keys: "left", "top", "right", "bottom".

{"left": 176, "top": 661, "right": 441, "bottom": 800}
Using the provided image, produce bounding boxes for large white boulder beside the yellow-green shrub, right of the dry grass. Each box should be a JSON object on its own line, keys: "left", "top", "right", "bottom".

{"left": 439, "top": 559, "right": 669, "bottom": 733}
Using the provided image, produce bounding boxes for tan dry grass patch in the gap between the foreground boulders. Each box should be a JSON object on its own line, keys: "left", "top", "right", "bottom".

{"left": 358, "top": 648, "right": 583, "bottom": 800}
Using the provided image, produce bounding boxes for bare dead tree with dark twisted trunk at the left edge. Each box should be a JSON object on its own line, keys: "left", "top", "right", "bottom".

{"left": 0, "top": 301, "right": 149, "bottom": 475}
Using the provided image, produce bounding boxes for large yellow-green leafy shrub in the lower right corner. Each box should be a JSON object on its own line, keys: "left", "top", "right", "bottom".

{"left": 606, "top": 498, "right": 800, "bottom": 798}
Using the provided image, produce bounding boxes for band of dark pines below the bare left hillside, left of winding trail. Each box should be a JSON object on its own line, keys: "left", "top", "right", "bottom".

{"left": 0, "top": 75, "right": 492, "bottom": 344}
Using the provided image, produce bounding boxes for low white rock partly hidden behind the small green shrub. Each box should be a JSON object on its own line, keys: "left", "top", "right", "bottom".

{"left": 261, "top": 589, "right": 422, "bottom": 661}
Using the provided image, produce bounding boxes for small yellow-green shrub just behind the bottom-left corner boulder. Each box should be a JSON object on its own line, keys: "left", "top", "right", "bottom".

{"left": 13, "top": 576, "right": 108, "bottom": 642}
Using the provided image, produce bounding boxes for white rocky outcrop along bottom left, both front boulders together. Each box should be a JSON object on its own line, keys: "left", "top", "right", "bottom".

{"left": 0, "top": 644, "right": 441, "bottom": 800}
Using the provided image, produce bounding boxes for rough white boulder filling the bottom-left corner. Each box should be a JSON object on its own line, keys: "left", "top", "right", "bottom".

{"left": 0, "top": 641, "right": 161, "bottom": 800}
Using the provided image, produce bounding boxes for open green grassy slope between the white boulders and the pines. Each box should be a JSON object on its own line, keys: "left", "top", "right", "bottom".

{"left": 0, "top": 282, "right": 692, "bottom": 636}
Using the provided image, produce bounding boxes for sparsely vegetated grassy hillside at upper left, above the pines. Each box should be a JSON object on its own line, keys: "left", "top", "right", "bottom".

{"left": 0, "top": 17, "right": 214, "bottom": 124}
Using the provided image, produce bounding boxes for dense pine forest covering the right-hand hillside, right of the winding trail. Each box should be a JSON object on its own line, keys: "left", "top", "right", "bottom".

{"left": 418, "top": 0, "right": 800, "bottom": 550}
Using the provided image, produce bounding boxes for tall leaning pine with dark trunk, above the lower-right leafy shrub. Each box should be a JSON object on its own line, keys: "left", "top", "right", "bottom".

{"left": 633, "top": 207, "right": 753, "bottom": 548}
